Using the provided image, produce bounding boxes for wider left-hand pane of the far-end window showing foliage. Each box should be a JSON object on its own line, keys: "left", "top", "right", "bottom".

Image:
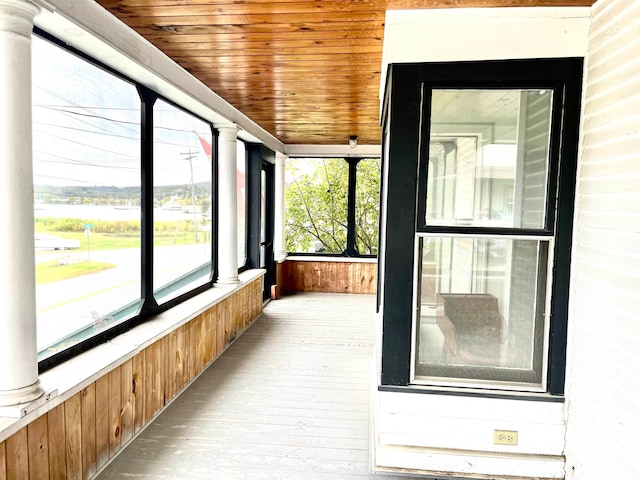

{"left": 285, "top": 158, "right": 349, "bottom": 253}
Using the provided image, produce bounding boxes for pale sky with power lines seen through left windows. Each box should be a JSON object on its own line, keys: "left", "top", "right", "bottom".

{"left": 32, "top": 37, "right": 212, "bottom": 187}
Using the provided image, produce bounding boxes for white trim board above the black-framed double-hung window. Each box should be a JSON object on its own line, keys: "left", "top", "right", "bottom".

{"left": 380, "top": 7, "right": 591, "bottom": 99}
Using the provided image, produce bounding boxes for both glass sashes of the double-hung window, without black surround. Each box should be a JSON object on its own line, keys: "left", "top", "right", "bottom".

{"left": 414, "top": 89, "right": 554, "bottom": 388}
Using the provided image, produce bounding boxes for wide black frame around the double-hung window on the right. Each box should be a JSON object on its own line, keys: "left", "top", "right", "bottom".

{"left": 379, "top": 57, "right": 584, "bottom": 396}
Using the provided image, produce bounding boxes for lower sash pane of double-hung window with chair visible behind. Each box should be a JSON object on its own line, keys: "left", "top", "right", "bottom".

{"left": 415, "top": 237, "right": 549, "bottom": 384}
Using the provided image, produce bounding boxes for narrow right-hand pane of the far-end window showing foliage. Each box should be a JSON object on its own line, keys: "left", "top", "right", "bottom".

{"left": 356, "top": 158, "right": 380, "bottom": 255}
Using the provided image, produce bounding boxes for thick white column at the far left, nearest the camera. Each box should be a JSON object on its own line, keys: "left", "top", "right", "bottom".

{"left": 0, "top": 0, "right": 43, "bottom": 406}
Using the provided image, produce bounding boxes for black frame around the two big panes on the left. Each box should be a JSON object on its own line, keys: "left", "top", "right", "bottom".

{"left": 33, "top": 27, "right": 229, "bottom": 373}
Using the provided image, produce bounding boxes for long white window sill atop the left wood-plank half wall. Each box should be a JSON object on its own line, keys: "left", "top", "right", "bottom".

{"left": 0, "top": 269, "right": 264, "bottom": 442}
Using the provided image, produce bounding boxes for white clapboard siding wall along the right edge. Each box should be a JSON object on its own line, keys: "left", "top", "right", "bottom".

{"left": 566, "top": 0, "right": 640, "bottom": 480}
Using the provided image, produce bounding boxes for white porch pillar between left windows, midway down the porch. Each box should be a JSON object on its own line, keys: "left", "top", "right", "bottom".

{"left": 216, "top": 124, "right": 240, "bottom": 284}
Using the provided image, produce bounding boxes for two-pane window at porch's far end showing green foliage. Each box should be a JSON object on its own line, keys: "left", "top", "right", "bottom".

{"left": 285, "top": 158, "right": 380, "bottom": 256}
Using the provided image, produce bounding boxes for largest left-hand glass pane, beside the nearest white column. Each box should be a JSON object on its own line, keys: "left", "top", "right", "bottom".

{"left": 33, "top": 37, "right": 141, "bottom": 358}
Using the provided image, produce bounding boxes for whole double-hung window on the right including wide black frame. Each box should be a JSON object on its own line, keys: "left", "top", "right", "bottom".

{"left": 382, "top": 59, "right": 582, "bottom": 394}
